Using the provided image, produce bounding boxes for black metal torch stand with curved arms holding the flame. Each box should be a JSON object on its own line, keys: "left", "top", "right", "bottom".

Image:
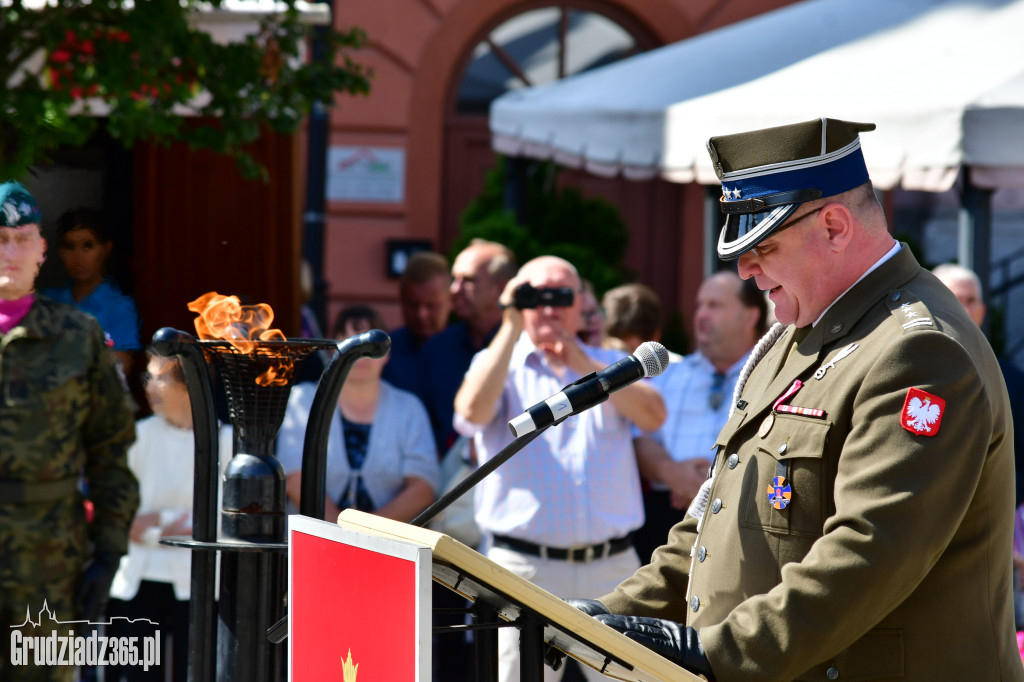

{"left": 153, "top": 328, "right": 390, "bottom": 682}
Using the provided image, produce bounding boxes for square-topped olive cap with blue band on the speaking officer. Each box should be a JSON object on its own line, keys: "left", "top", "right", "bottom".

{"left": 708, "top": 118, "right": 874, "bottom": 260}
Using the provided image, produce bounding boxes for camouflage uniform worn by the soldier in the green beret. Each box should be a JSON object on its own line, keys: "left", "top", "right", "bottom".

{"left": 0, "top": 297, "right": 138, "bottom": 680}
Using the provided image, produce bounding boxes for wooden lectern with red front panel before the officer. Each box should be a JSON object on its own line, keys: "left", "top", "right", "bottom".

{"left": 289, "top": 509, "right": 700, "bottom": 682}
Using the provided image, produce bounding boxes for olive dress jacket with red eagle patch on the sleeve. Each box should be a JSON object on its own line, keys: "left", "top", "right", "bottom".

{"left": 601, "top": 245, "right": 1024, "bottom": 682}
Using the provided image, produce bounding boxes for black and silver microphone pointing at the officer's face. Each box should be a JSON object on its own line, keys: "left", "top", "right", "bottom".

{"left": 509, "top": 341, "right": 669, "bottom": 438}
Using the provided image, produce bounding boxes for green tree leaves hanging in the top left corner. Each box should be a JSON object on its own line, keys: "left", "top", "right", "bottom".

{"left": 0, "top": 0, "right": 371, "bottom": 177}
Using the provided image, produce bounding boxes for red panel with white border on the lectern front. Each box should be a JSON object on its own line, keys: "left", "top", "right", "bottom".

{"left": 288, "top": 515, "right": 431, "bottom": 682}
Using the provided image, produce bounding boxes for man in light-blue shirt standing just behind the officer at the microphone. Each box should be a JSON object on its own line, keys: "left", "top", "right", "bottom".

{"left": 633, "top": 270, "right": 768, "bottom": 563}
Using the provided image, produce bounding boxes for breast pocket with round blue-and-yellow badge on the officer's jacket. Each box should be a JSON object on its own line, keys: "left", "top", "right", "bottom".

{"left": 741, "top": 414, "right": 829, "bottom": 538}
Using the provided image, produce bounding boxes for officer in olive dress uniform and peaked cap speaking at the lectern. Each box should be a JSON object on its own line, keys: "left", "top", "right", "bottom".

{"left": 573, "top": 119, "right": 1024, "bottom": 682}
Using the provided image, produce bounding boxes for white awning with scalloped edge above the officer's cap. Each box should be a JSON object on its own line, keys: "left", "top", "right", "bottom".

{"left": 490, "top": 0, "right": 1024, "bottom": 191}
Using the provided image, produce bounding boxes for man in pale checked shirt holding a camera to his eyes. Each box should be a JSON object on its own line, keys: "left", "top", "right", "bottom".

{"left": 455, "top": 256, "right": 666, "bottom": 681}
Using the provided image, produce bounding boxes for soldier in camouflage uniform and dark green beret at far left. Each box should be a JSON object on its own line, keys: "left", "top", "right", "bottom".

{"left": 0, "top": 182, "right": 138, "bottom": 680}
